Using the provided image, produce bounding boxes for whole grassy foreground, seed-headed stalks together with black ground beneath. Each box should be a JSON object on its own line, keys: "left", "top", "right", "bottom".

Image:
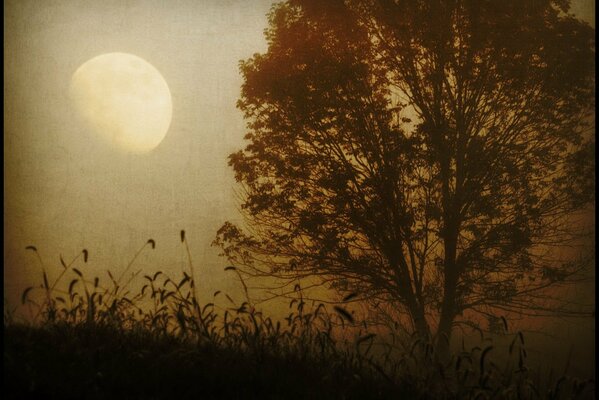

{"left": 3, "top": 231, "right": 595, "bottom": 399}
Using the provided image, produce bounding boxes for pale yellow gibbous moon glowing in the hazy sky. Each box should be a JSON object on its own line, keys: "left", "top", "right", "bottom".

{"left": 70, "top": 53, "right": 173, "bottom": 153}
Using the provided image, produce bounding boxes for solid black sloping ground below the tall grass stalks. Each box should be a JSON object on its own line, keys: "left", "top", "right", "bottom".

{"left": 2, "top": 324, "right": 408, "bottom": 399}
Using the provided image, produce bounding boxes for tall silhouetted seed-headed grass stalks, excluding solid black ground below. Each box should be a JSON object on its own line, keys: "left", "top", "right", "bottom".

{"left": 4, "top": 231, "right": 595, "bottom": 399}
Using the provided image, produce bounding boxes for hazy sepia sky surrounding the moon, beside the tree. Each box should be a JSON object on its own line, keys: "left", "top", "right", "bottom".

{"left": 4, "top": 0, "right": 595, "bottom": 322}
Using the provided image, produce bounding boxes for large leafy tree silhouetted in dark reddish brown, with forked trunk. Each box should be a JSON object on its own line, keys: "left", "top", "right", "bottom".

{"left": 215, "top": 0, "right": 595, "bottom": 352}
